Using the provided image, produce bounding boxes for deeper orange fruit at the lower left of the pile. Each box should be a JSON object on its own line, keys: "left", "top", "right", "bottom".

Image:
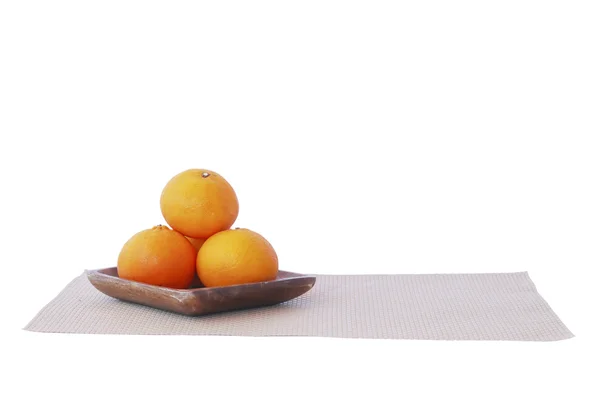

{"left": 117, "top": 225, "right": 197, "bottom": 289}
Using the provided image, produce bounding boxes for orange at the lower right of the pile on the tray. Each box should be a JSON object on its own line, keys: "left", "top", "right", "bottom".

{"left": 196, "top": 229, "right": 279, "bottom": 287}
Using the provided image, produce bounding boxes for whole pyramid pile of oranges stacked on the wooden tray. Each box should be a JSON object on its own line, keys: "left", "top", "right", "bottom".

{"left": 117, "top": 169, "right": 279, "bottom": 289}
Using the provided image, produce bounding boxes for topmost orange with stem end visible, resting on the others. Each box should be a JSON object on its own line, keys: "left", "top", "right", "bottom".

{"left": 160, "top": 169, "right": 239, "bottom": 239}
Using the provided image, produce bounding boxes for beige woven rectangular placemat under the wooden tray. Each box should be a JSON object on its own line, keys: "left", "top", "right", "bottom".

{"left": 25, "top": 272, "right": 573, "bottom": 341}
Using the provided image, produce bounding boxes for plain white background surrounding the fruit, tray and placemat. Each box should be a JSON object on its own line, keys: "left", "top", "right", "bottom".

{"left": 0, "top": 0, "right": 600, "bottom": 399}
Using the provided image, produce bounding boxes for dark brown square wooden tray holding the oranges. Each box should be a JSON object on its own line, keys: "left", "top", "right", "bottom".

{"left": 86, "top": 267, "right": 316, "bottom": 315}
